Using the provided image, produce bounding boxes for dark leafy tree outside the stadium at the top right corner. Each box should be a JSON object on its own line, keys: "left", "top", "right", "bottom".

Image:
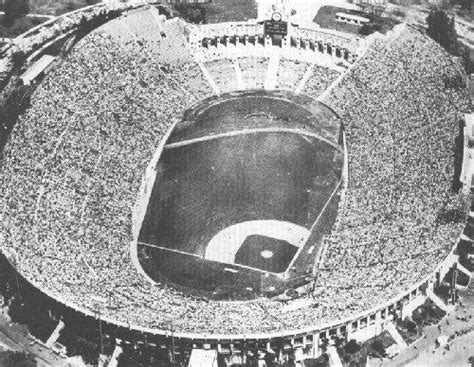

{"left": 426, "top": 9, "right": 460, "bottom": 56}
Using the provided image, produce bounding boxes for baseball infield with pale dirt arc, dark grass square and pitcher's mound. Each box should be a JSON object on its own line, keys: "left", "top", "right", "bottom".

{"left": 205, "top": 220, "right": 310, "bottom": 273}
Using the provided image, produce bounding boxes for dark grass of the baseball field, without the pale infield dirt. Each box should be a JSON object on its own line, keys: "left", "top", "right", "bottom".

{"left": 139, "top": 95, "right": 342, "bottom": 300}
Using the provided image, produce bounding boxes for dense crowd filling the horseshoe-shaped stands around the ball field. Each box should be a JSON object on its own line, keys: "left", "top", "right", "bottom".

{"left": 0, "top": 7, "right": 468, "bottom": 340}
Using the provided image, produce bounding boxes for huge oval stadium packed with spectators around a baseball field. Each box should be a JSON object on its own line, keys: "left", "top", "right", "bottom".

{"left": 0, "top": 0, "right": 470, "bottom": 366}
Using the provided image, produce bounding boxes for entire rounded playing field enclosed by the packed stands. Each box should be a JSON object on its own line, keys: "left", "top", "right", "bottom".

{"left": 132, "top": 91, "right": 344, "bottom": 300}
